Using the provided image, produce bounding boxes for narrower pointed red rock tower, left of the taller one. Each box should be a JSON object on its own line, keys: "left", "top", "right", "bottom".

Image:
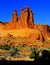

{"left": 9, "top": 10, "right": 18, "bottom": 29}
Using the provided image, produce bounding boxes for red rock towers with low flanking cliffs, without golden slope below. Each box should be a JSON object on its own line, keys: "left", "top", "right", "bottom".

{"left": 0, "top": 6, "right": 50, "bottom": 40}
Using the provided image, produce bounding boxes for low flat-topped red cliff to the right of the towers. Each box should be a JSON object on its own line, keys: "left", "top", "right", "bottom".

{"left": 34, "top": 24, "right": 49, "bottom": 36}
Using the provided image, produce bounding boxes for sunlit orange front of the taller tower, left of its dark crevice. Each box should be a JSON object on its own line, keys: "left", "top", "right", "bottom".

{"left": 20, "top": 9, "right": 28, "bottom": 28}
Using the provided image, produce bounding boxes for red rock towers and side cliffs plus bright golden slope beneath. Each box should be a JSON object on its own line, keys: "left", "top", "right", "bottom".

{"left": 0, "top": 6, "right": 50, "bottom": 40}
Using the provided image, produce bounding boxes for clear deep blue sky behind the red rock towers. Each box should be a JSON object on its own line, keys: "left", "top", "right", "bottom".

{"left": 0, "top": 0, "right": 50, "bottom": 25}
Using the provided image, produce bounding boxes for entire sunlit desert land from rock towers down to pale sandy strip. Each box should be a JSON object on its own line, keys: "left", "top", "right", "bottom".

{"left": 0, "top": 6, "right": 50, "bottom": 61}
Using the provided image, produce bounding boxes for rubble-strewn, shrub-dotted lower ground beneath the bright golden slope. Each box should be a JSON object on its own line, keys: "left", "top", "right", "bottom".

{"left": 0, "top": 34, "right": 50, "bottom": 60}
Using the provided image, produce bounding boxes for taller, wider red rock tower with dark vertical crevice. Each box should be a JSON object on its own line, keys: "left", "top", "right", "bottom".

{"left": 18, "top": 7, "right": 34, "bottom": 28}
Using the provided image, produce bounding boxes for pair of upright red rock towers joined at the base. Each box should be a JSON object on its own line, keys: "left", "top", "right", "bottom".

{"left": 9, "top": 7, "right": 34, "bottom": 29}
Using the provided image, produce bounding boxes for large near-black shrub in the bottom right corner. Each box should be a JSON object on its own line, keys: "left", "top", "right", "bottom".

{"left": 36, "top": 50, "right": 50, "bottom": 61}
